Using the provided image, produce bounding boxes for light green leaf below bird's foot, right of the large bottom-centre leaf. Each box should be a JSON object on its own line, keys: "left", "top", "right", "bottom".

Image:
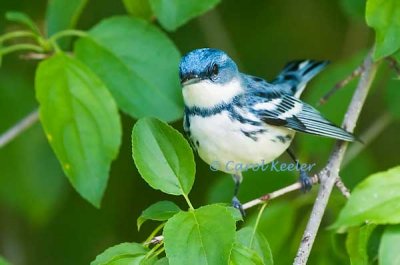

{"left": 236, "top": 227, "right": 274, "bottom": 265}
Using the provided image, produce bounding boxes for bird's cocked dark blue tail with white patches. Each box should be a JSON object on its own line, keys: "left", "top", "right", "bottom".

{"left": 272, "top": 60, "right": 329, "bottom": 97}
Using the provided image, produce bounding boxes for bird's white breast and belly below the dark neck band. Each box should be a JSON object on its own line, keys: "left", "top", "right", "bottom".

{"left": 189, "top": 111, "right": 295, "bottom": 173}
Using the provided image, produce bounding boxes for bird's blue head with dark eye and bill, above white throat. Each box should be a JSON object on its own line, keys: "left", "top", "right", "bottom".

{"left": 179, "top": 48, "right": 239, "bottom": 85}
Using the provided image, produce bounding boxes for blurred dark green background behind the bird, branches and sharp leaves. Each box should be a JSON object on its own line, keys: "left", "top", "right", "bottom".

{"left": 0, "top": 0, "right": 400, "bottom": 265}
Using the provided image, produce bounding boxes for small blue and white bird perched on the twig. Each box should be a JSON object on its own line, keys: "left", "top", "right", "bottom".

{"left": 179, "top": 48, "right": 355, "bottom": 214}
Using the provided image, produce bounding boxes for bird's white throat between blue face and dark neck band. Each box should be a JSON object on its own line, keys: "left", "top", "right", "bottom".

{"left": 182, "top": 78, "right": 243, "bottom": 108}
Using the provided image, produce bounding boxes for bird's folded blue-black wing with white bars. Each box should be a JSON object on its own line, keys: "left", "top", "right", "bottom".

{"left": 249, "top": 95, "right": 355, "bottom": 141}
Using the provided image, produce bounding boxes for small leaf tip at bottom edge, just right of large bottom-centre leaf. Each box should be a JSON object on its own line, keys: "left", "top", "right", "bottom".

{"left": 229, "top": 243, "right": 264, "bottom": 265}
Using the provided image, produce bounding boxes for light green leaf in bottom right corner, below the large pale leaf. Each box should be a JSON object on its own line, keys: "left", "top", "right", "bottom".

{"left": 379, "top": 225, "right": 400, "bottom": 265}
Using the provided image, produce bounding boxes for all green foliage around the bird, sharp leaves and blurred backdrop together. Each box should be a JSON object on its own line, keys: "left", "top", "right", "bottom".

{"left": 0, "top": 0, "right": 400, "bottom": 264}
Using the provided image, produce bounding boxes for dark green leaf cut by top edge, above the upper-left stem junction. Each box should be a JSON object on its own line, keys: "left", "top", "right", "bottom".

{"left": 46, "top": 0, "right": 88, "bottom": 36}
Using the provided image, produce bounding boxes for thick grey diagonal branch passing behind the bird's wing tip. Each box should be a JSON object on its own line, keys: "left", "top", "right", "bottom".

{"left": 294, "top": 52, "right": 377, "bottom": 265}
